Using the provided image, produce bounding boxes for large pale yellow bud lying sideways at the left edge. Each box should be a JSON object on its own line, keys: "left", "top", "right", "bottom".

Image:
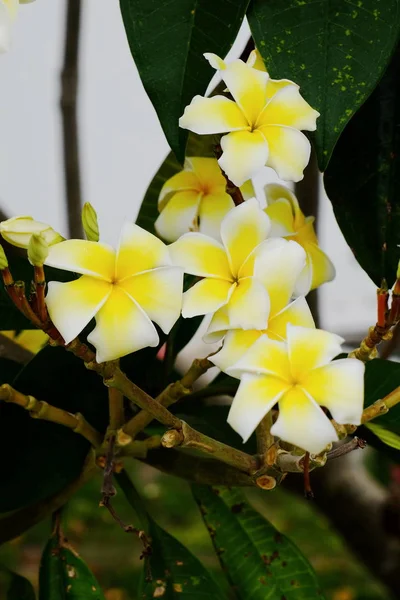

{"left": 0, "top": 217, "right": 64, "bottom": 249}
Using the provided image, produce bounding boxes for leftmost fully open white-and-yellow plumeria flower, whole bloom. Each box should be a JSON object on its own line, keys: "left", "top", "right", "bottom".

{"left": 45, "top": 217, "right": 183, "bottom": 362}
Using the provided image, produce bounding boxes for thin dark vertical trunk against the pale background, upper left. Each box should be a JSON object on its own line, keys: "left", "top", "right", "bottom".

{"left": 60, "top": 0, "right": 83, "bottom": 238}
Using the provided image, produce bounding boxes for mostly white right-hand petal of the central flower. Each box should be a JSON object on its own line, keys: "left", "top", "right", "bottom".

{"left": 254, "top": 238, "right": 306, "bottom": 315}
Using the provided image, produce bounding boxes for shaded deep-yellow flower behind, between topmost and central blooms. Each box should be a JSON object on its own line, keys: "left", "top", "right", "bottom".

{"left": 155, "top": 157, "right": 234, "bottom": 242}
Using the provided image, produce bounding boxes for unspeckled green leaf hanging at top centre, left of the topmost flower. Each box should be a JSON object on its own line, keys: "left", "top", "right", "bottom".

{"left": 120, "top": 0, "right": 249, "bottom": 162}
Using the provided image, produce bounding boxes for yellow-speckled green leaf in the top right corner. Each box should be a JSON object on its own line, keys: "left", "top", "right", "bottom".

{"left": 247, "top": 0, "right": 400, "bottom": 173}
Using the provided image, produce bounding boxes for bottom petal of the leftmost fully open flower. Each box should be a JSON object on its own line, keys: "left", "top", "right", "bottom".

{"left": 88, "top": 286, "right": 159, "bottom": 362}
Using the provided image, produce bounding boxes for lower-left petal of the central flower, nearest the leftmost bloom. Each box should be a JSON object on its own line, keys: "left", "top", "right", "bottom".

{"left": 182, "top": 279, "right": 235, "bottom": 319}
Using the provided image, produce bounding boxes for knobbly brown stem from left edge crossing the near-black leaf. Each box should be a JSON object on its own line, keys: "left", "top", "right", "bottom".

{"left": 0, "top": 383, "right": 103, "bottom": 448}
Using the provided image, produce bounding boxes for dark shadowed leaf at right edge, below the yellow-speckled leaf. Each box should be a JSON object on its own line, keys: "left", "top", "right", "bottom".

{"left": 324, "top": 44, "right": 400, "bottom": 286}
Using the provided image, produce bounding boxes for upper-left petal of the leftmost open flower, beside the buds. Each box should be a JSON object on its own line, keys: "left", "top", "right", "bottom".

{"left": 45, "top": 240, "right": 115, "bottom": 282}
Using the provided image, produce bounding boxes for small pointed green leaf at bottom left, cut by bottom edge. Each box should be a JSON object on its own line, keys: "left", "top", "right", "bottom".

{"left": 39, "top": 535, "right": 105, "bottom": 600}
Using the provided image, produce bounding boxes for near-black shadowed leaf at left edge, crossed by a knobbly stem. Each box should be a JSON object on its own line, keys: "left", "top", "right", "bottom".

{"left": 0, "top": 347, "right": 108, "bottom": 512}
